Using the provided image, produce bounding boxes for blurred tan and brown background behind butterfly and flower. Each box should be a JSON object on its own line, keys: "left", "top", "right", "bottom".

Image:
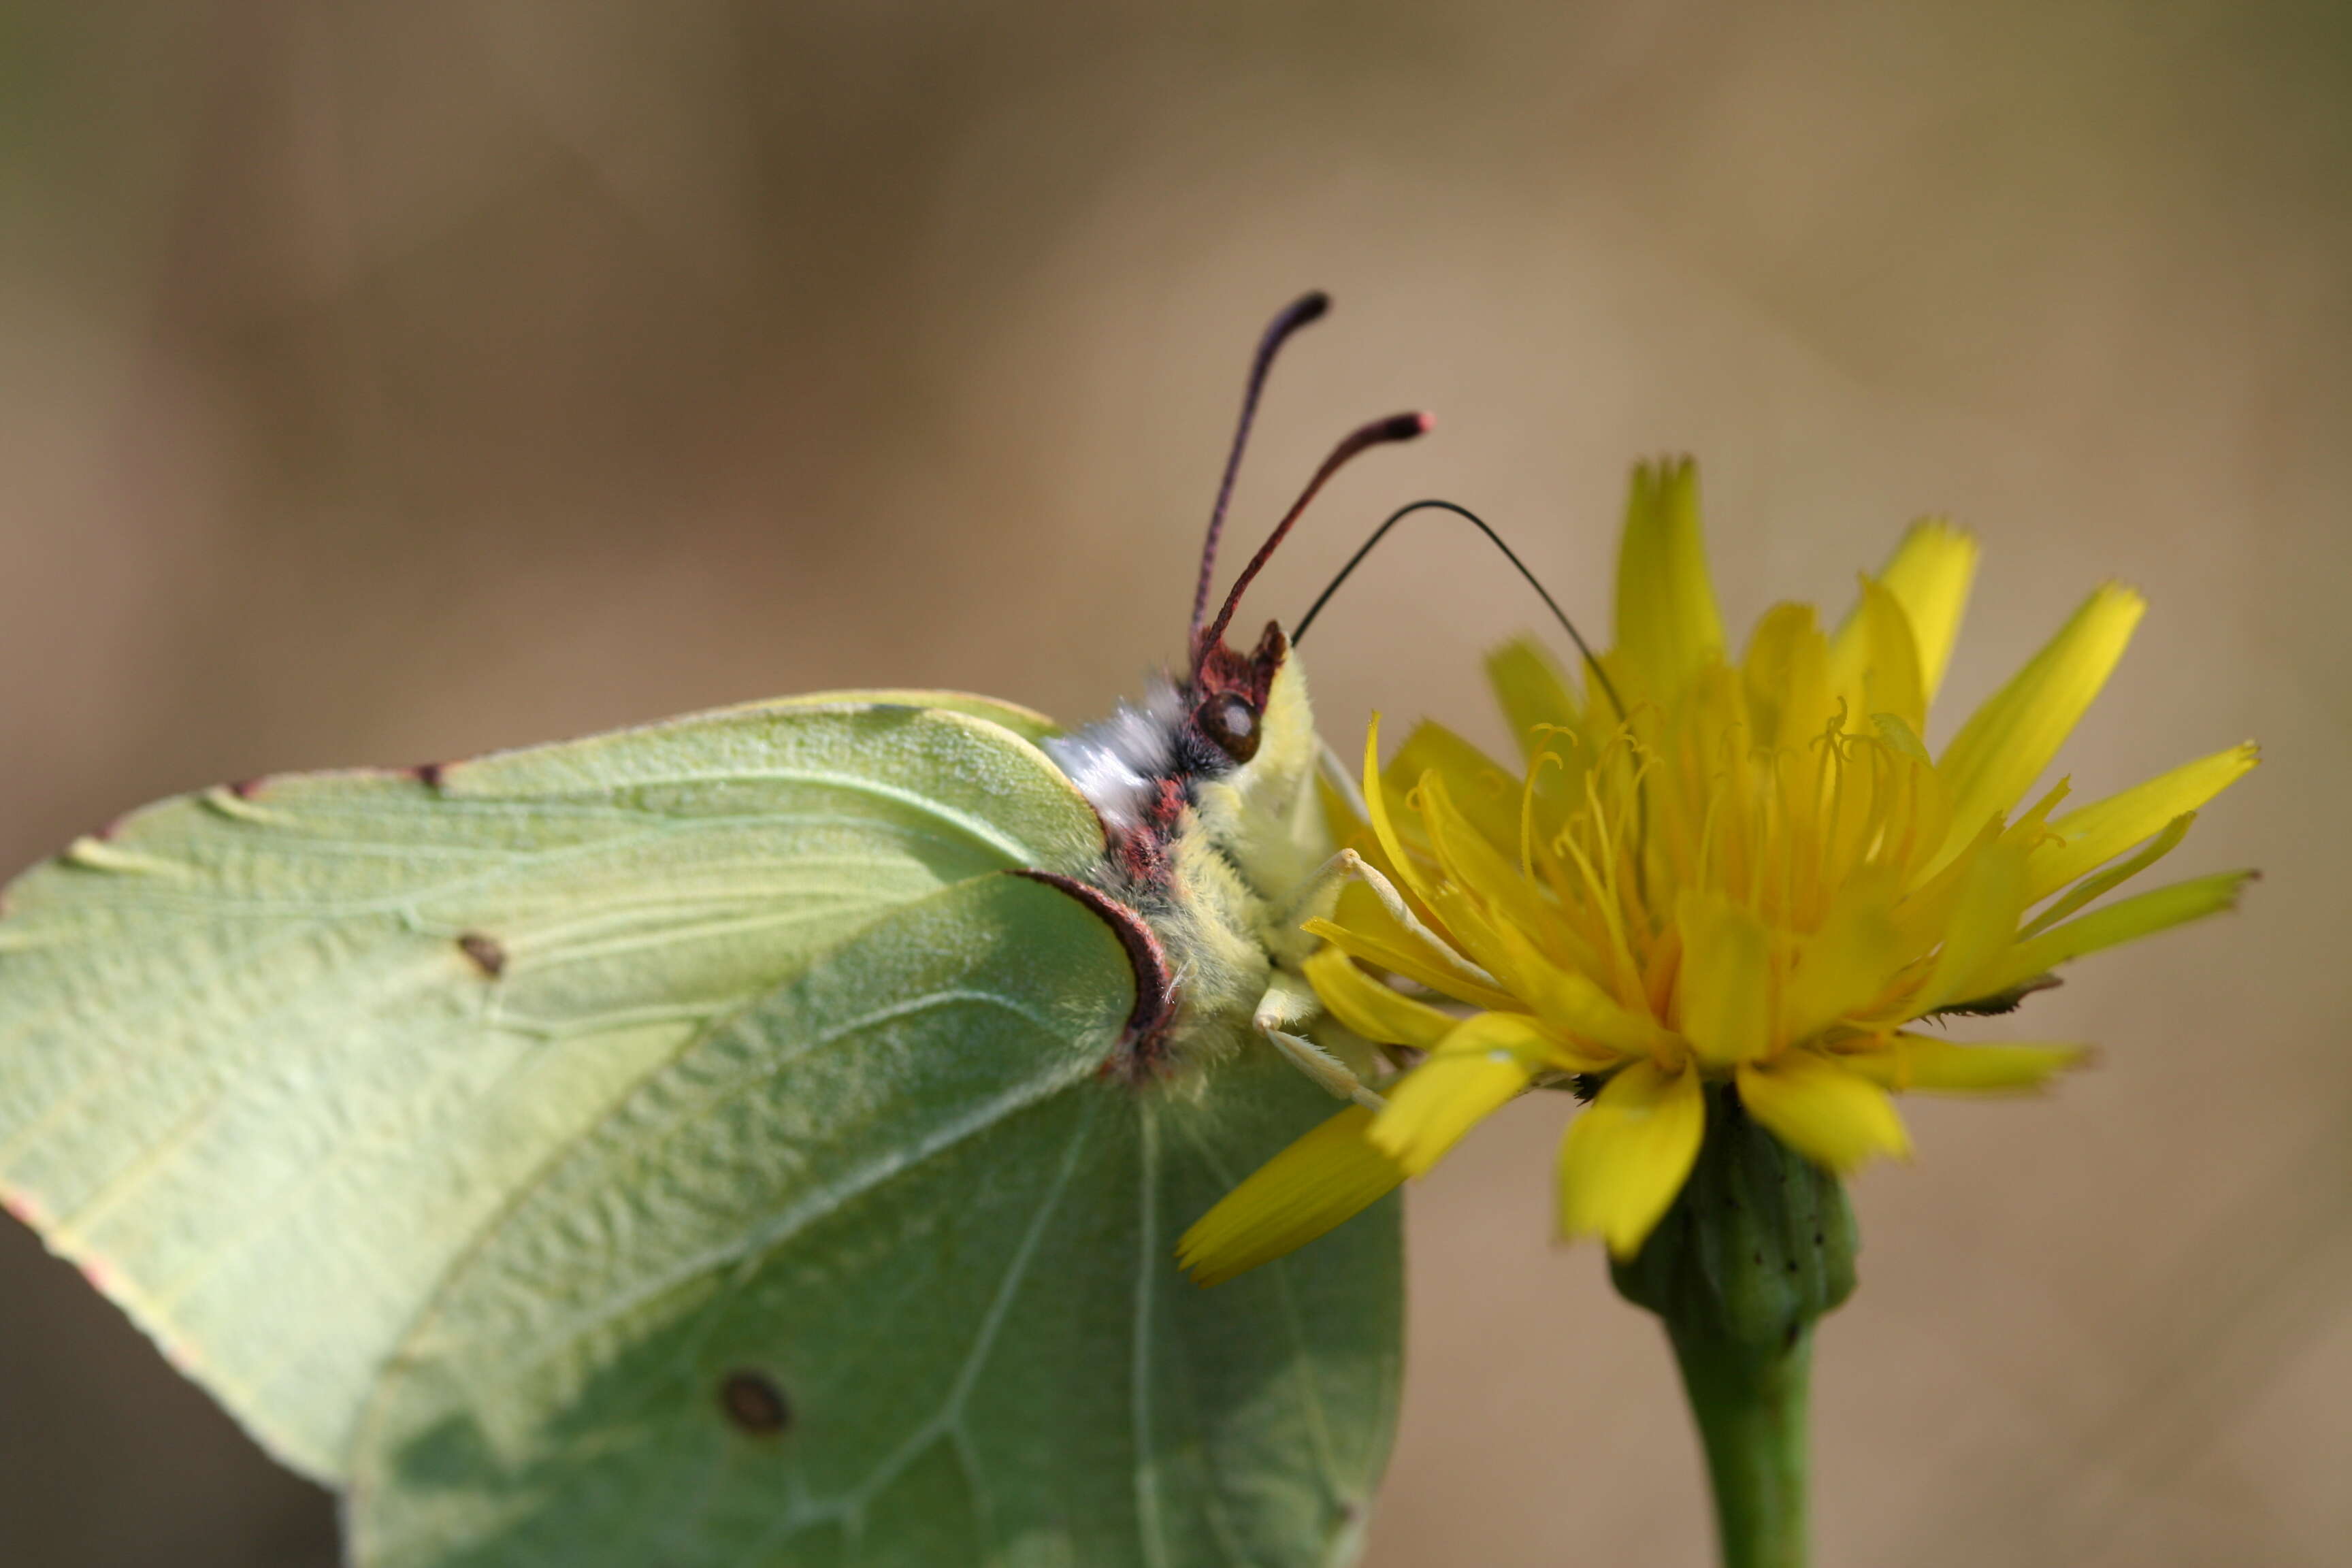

{"left": 0, "top": 0, "right": 2352, "bottom": 1568}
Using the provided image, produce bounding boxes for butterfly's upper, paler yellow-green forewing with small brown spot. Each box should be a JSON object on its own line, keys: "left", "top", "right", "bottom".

{"left": 0, "top": 698, "right": 1100, "bottom": 1479}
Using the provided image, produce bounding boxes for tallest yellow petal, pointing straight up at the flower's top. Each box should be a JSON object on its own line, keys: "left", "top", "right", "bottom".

{"left": 1616, "top": 459, "right": 1724, "bottom": 700}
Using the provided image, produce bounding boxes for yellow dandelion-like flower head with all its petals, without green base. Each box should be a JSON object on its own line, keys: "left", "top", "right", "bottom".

{"left": 1181, "top": 463, "right": 2255, "bottom": 1284}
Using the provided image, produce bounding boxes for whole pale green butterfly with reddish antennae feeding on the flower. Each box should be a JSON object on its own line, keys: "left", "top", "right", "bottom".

{"left": 0, "top": 294, "right": 1428, "bottom": 1568}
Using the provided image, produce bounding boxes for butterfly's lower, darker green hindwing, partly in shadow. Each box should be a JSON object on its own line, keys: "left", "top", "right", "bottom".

{"left": 353, "top": 877, "right": 1399, "bottom": 1568}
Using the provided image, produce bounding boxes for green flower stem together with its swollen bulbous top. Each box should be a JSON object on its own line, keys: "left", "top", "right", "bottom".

{"left": 1611, "top": 1083, "right": 1861, "bottom": 1568}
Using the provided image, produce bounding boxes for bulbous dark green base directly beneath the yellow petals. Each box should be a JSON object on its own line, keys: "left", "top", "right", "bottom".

{"left": 1609, "top": 1083, "right": 1861, "bottom": 1345}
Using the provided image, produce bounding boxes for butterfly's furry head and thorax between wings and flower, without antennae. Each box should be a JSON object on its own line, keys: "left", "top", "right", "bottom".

{"left": 1047, "top": 625, "right": 1331, "bottom": 1081}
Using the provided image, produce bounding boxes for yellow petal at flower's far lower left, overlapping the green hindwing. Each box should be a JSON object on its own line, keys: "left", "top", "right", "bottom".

{"left": 1176, "top": 1105, "right": 1404, "bottom": 1286}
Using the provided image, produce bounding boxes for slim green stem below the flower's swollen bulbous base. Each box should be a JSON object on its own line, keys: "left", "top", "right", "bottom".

{"left": 1667, "top": 1324, "right": 1814, "bottom": 1568}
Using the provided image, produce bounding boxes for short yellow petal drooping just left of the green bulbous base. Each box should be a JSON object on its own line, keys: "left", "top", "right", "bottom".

{"left": 1559, "top": 1062, "right": 1708, "bottom": 1258}
